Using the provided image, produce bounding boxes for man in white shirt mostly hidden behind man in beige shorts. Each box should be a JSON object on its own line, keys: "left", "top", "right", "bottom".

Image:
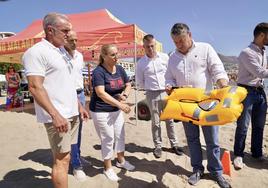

{"left": 64, "top": 30, "right": 90, "bottom": 181}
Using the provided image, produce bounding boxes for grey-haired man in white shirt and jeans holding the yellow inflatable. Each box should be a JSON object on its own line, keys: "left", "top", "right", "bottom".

{"left": 165, "top": 23, "right": 230, "bottom": 188}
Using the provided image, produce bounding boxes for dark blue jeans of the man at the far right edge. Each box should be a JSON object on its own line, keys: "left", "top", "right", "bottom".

{"left": 234, "top": 87, "right": 267, "bottom": 158}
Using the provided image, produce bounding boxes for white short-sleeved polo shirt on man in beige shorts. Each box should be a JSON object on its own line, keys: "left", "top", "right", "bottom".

{"left": 22, "top": 39, "right": 78, "bottom": 123}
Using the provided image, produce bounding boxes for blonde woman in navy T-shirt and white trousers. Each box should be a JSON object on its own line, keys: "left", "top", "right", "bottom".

{"left": 89, "top": 44, "right": 135, "bottom": 181}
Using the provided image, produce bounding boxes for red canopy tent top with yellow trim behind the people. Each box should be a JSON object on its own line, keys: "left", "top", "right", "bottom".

{"left": 0, "top": 9, "right": 162, "bottom": 63}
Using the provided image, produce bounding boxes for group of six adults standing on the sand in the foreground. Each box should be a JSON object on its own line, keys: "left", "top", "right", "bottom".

{"left": 23, "top": 13, "right": 268, "bottom": 188}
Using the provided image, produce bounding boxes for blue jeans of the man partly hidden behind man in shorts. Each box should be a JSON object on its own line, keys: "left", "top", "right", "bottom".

{"left": 71, "top": 91, "right": 86, "bottom": 169}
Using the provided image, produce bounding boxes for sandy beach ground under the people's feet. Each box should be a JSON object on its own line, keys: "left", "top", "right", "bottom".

{"left": 0, "top": 88, "right": 268, "bottom": 188}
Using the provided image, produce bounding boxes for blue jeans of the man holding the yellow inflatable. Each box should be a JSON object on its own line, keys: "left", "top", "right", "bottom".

{"left": 183, "top": 122, "right": 222, "bottom": 176}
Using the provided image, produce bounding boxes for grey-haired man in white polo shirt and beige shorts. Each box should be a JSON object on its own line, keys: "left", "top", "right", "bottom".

{"left": 22, "top": 13, "right": 88, "bottom": 188}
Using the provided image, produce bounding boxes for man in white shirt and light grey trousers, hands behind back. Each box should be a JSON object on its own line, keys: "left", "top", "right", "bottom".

{"left": 136, "top": 34, "right": 183, "bottom": 158}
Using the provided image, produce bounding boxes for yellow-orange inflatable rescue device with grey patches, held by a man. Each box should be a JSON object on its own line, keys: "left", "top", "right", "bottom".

{"left": 160, "top": 86, "right": 247, "bottom": 126}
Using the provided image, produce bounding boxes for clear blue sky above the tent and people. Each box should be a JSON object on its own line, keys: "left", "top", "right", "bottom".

{"left": 0, "top": 0, "right": 268, "bottom": 55}
